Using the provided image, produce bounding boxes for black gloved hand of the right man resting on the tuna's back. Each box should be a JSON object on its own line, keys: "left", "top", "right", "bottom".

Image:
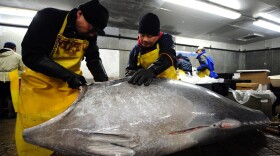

{"left": 128, "top": 69, "right": 155, "bottom": 86}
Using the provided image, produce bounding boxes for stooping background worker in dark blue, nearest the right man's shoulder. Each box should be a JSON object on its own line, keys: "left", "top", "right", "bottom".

{"left": 176, "top": 53, "right": 192, "bottom": 75}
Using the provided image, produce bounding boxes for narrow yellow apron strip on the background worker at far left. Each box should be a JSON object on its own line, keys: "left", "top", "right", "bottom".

{"left": 8, "top": 69, "right": 19, "bottom": 112}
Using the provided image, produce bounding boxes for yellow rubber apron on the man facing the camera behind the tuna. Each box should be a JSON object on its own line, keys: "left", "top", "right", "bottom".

{"left": 137, "top": 44, "right": 177, "bottom": 79}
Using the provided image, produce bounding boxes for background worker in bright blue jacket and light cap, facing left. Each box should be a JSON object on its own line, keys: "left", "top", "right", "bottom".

{"left": 196, "top": 46, "right": 218, "bottom": 78}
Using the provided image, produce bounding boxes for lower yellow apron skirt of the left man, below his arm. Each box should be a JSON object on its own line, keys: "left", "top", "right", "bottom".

{"left": 16, "top": 69, "right": 79, "bottom": 156}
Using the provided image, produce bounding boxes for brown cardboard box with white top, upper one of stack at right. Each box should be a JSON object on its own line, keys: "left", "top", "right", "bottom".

{"left": 237, "top": 70, "right": 270, "bottom": 84}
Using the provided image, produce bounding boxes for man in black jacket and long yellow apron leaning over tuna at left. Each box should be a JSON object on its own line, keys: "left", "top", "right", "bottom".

{"left": 16, "top": 0, "right": 109, "bottom": 155}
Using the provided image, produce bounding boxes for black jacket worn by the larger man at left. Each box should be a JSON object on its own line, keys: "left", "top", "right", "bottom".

{"left": 21, "top": 8, "right": 108, "bottom": 81}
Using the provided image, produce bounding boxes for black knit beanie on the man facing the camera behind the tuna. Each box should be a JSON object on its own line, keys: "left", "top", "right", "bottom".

{"left": 138, "top": 13, "right": 160, "bottom": 36}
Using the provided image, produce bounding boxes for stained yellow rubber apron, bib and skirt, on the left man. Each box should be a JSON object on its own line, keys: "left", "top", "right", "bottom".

{"left": 15, "top": 14, "right": 89, "bottom": 156}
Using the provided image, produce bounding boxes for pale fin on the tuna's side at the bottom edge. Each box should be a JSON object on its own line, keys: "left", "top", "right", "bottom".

{"left": 87, "top": 142, "right": 135, "bottom": 156}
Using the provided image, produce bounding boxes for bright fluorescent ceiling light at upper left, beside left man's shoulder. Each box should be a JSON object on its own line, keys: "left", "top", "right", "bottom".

{"left": 0, "top": 6, "right": 37, "bottom": 17}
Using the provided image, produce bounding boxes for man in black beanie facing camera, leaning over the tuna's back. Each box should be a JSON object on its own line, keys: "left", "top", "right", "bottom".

{"left": 126, "top": 13, "right": 177, "bottom": 86}
